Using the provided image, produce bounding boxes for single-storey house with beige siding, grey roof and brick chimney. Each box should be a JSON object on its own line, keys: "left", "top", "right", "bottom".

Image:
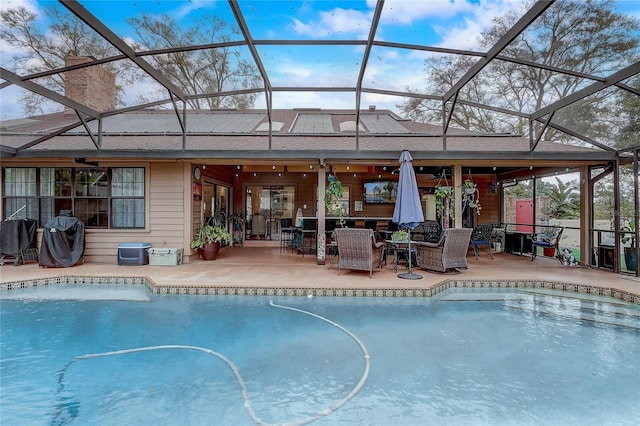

{"left": 0, "top": 58, "right": 616, "bottom": 264}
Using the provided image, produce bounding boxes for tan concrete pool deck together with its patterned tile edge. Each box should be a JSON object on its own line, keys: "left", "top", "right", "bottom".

{"left": 0, "top": 243, "right": 640, "bottom": 304}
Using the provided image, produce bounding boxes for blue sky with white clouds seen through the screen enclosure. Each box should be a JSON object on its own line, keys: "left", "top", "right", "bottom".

{"left": 0, "top": 0, "right": 640, "bottom": 120}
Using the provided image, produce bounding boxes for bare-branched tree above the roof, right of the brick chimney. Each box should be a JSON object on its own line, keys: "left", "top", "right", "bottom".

{"left": 128, "top": 14, "right": 262, "bottom": 109}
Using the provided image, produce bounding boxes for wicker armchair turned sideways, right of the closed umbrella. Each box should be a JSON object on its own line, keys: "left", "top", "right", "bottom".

{"left": 415, "top": 228, "right": 473, "bottom": 272}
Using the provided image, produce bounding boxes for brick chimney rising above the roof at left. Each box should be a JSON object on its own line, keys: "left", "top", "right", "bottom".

{"left": 64, "top": 56, "right": 116, "bottom": 115}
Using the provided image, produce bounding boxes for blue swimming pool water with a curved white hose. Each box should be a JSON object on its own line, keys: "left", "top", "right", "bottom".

{"left": 0, "top": 286, "right": 640, "bottom": 426}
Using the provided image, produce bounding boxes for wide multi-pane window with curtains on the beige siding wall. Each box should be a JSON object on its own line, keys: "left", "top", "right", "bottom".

{"left": 3, "top": 167, "right": 145, "bottom": 229}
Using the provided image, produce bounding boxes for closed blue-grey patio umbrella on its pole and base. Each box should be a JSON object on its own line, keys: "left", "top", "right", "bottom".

{"left": 393, "top": 150, "right": 424, "bottom": 280}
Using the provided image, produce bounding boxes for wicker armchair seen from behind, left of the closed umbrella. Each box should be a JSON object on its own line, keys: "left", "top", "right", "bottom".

{"left": 335, "top": 228, "right": 384, "bottom": 278}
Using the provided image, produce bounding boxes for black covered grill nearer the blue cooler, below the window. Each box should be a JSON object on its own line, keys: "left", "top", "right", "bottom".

{"left": 40, "top": 216, "right": 84, "bottom": 268}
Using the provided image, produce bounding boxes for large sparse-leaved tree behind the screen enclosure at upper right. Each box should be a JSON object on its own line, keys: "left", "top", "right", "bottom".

{"left": 399, "top": 0, "right": 640, "bottom": 146}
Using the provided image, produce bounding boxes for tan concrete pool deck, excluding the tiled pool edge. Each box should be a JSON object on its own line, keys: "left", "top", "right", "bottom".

{"left": 0, "top": 244, "right": 640, "bottom": 296}
